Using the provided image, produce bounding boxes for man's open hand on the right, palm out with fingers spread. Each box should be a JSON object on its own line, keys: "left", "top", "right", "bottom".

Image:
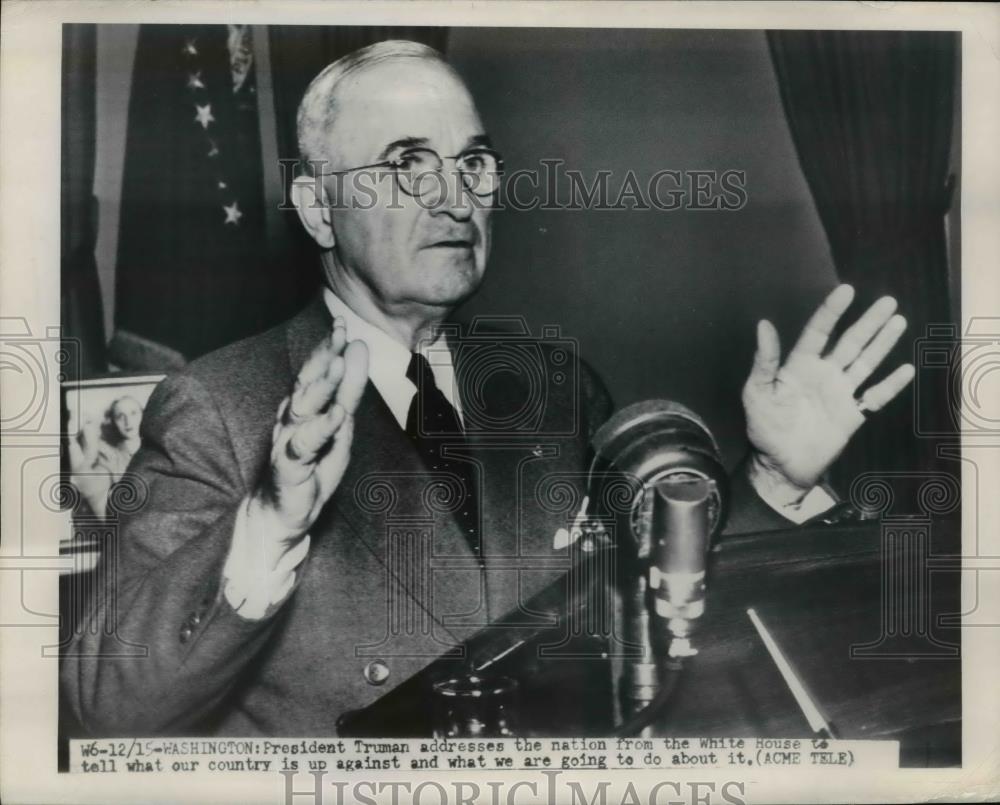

{"left": 743, "top": 285, "right": 914, "bottom": 502}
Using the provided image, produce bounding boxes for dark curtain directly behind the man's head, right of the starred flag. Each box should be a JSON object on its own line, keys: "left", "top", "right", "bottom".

{"left": 268, "top": 25, "right": 448, "bottom": 276}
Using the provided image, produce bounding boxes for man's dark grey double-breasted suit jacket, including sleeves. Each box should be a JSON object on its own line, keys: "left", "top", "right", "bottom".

{"left": 61, "top": 299, "right": 787, "bottom": 735}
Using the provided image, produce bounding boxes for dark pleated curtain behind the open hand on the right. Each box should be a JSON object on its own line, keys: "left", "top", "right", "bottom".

{"left": 767, "top": 31, "right": 959, "bottom": 484}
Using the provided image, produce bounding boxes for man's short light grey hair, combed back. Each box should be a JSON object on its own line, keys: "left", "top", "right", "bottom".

{"left": 296, "top": 39, "right": 451, "bottom": 174}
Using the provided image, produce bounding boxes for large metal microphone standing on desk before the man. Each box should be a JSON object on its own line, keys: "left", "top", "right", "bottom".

{"left": 588, "top": 400, "right": 729, "bottom": 734}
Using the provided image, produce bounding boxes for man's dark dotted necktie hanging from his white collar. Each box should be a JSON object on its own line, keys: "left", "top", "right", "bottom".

{"left": 406, "top": 353, "right": 482, "bottom": 563}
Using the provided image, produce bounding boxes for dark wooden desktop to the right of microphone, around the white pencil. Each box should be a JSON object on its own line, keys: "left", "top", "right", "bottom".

{"left": 662, "top": 520, "right": 962, "bottom": 765}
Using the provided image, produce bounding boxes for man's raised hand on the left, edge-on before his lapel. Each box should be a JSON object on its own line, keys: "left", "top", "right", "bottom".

{"left": 254, "top": 317, "right": 368, "bottom": 540}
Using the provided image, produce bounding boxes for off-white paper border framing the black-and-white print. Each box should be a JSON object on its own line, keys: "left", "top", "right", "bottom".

{"left": 0, "top": 0, "right": 1000, "bottom": 803}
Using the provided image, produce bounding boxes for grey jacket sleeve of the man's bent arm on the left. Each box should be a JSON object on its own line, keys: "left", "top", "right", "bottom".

{"left": 61, "top": 374, "right": 290, "bottom": 735}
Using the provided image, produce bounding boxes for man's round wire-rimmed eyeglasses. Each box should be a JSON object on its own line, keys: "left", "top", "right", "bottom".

{"left": 322, "top": 148, "right": 503, "bottom": 203}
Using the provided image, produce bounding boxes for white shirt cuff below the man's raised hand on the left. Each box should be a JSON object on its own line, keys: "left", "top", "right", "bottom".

{"left": 222, "top": 498, "right": 310, "bottom": 620}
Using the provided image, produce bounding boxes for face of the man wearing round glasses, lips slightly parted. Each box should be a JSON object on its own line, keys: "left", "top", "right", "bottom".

{"left": 325, "top": 59, "right": 492, "bottom": 307}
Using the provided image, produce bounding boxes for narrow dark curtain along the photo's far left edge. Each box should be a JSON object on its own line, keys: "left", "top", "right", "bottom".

{"left": 60, "top": 25, "right": 107, "bottom": 379}
